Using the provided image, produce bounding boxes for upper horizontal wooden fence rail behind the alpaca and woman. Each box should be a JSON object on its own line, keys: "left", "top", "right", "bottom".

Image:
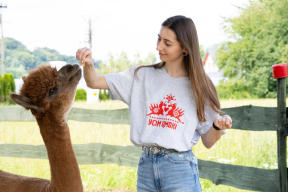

{"left": 0, "top": 105, "right": 277, "bottom": 131}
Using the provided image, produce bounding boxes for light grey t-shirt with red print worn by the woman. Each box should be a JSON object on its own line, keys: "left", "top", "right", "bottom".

{"left": 104, "top": 67, "right": 226, "bottom": 151}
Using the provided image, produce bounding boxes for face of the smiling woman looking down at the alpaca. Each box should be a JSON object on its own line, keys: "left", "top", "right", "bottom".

{"left": 156, "top": 27, "right": 184, "bottom": 62}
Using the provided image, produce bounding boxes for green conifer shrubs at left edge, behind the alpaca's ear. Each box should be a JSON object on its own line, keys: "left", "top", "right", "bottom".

{"left": 0, "top": 73, "right": 15, "bottom": 104}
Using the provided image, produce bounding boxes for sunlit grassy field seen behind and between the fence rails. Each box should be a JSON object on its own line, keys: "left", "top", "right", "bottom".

{"left": 0, "top": 99, "right": 284, "bottom": 192}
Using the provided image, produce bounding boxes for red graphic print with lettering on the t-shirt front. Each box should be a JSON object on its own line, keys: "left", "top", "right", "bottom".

{"left": 147, "top": 94, "right": 184, "bottom": 130}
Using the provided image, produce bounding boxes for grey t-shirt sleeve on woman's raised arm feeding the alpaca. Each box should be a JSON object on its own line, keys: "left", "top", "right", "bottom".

{"left": 104, "top": 68, "right": 135, "bottom": 106}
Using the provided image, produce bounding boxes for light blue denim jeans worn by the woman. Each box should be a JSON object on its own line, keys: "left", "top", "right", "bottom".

{"left": 137, "top": 150, "right": 202, "bottom": 192}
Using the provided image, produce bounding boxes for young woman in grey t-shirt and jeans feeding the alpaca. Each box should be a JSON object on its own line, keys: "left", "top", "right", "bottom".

{"left": 76, "top": 16, "right": 232, "bottom": 192}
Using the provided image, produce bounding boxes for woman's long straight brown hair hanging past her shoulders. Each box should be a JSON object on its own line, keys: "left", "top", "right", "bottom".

{"left": 134, "top": 15, "right": 223, "bottom": 122}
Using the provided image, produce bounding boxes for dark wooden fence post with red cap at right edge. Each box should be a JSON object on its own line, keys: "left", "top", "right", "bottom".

{"left": 272, "top": 64, "right": 288, "bottom": 192}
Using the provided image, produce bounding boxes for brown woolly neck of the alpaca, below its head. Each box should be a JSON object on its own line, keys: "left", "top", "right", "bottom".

{"left": 37, "top": 115, "right": 83, "bottom": 191}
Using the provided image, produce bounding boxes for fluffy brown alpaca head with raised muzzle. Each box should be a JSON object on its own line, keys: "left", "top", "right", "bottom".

{"left": 10, "top": 65, "right": 82, "bottom": 121}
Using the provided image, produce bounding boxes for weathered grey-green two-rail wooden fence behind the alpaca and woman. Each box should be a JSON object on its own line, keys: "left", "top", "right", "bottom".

{"left": 0, "top": 104, "right": 287, "bottom": 192}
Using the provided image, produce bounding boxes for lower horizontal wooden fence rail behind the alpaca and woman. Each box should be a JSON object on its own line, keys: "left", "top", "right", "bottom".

{"left": 0, "top": 143, "right": 279, "bottom": 192}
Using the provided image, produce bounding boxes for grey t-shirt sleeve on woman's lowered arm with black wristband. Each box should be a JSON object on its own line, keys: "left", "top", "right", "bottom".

{"left": 192, "top": 105, "right": 227, "bottom": 145}
